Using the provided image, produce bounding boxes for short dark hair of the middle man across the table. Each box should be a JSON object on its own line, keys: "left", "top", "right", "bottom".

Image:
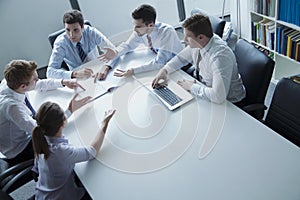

{"left": 131, "top": 4, "right": 156, "bottom": 25}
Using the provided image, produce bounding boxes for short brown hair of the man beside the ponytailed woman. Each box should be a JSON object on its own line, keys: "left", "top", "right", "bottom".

{"left": 4, "top": 60, "right": 37, "bottom": 90}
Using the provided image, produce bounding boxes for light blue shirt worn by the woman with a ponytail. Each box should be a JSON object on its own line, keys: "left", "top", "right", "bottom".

{"left": 33, "top": 136, "right": 96, "bottom": 200}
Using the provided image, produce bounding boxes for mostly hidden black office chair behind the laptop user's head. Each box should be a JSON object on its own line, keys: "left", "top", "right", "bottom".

{"left": 181, "top": 8, "right": 226, "bottom": 76}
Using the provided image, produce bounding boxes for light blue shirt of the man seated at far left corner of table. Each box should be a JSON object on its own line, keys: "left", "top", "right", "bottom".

{"left": 47, "top": 25, "right": 115, "bottom": 79}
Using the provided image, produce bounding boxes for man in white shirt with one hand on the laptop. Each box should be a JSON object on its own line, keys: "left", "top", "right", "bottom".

{"left": 152, "top": 14, "right": 246, "bottom": 103}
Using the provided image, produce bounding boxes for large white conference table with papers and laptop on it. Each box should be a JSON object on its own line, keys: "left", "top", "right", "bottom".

{"left": 30, "top": 50, "right": 300, "bottom": 200}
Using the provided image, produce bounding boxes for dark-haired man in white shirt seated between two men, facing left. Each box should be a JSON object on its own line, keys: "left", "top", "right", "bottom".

{"left": 102, "top": 4, "right": 183, "bottom": 77}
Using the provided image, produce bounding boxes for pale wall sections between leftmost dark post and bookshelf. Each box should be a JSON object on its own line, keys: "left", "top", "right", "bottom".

{"left": 78, "top": 0, "right": 230, "bottom": 37}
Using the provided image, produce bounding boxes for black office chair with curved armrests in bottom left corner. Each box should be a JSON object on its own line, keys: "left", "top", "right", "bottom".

{"left": 0, "top": 159, "right": 34, "bottom": 199}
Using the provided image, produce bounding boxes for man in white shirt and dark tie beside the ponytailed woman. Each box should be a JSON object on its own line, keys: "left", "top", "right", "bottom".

{"left": 0, "top": 60, "right": 91, "bottom": 166}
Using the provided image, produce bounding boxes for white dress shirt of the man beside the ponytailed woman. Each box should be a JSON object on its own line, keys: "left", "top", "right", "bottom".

{"left": 0, "top": 79, "right": 63, "bottom": 159}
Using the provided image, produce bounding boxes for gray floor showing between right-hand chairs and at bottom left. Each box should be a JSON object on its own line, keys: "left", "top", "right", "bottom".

{"left": 10, "top": 82, "right": 276, "bottom": 200}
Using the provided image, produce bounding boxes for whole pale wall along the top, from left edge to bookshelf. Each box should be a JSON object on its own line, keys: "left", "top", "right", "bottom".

{"left": 0, "top": 0, "right": 229, "bottom": 79}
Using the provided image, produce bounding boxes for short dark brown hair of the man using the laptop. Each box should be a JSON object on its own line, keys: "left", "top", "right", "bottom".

{"left": 182, "top": 14, "right": 213, "bottom": 38}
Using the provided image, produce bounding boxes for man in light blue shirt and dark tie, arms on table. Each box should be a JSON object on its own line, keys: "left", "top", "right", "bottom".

{"left": 47, "top": 10, "right": 115, "bottom": 80}
